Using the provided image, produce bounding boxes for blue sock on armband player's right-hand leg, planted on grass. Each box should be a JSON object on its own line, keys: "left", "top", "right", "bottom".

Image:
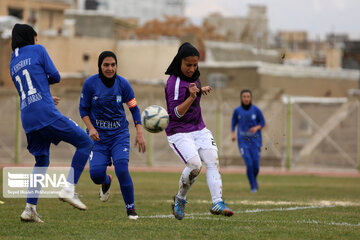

{"left": 114, "top": 160, "right": 135, "bottom": 210}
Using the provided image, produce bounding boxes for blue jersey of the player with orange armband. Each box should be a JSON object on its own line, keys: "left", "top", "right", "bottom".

{"left": 79, "top": 74, "right": 141, "bottom": 141}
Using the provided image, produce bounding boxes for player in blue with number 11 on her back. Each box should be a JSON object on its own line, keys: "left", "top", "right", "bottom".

{"left": 10, "top": 24, "right": 93, "bottom": 222}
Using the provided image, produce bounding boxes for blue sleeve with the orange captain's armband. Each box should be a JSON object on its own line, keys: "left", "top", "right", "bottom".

{"left": 121, "top": 78, "right": 141, "bottom": 126}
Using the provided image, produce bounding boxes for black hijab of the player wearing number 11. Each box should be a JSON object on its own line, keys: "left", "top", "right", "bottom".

{"left": 11, "top": 23, "right": 37, "bottom": 51}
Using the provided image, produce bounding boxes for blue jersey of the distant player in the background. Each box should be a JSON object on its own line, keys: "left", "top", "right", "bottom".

{"left": 231, "top": 105, "right": 265, "bottom": 147}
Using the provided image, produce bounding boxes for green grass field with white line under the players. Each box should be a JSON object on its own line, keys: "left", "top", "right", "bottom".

{"left": 0, "top": 171, "right": 360, "bottom": 239}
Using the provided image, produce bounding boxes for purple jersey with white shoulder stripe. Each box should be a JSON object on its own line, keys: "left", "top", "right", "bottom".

{"left": 165, "top": 75, "right": 205, "bottom": 136}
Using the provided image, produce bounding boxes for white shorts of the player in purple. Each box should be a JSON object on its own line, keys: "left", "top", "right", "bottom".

{"left": 168, "top": 128, "right": 218, "bottom": 163}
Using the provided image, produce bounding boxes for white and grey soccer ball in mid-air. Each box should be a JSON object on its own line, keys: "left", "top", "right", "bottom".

{"left": 141, "top": 105, "right": 169, "bottom": 133}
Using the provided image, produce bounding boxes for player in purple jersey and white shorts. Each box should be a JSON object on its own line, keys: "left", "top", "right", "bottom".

{"left": 165, "top": 43, "right": 234, "bottom": 220}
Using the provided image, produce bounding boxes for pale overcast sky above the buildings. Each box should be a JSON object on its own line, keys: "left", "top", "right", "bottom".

{"left": 185, "top": 0, "right": 360, "bottom": 40}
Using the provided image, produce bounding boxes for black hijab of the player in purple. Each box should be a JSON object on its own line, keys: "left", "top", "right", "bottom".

{"left": 165, "top": 42, "right": 200, "bottom": 82}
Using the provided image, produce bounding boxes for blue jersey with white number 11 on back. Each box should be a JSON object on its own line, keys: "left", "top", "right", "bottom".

{"left": 10, "top": 44, "right": 62, "bottom": 133}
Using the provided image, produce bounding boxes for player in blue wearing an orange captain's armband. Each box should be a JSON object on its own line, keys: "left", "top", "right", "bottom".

{"left": 80, "top": 51, "right": 146, "bottom": 220}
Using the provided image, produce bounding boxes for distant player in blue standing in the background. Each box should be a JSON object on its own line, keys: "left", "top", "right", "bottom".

{"left": 231, "top": 89, "right": 265, "bottom": 193}
